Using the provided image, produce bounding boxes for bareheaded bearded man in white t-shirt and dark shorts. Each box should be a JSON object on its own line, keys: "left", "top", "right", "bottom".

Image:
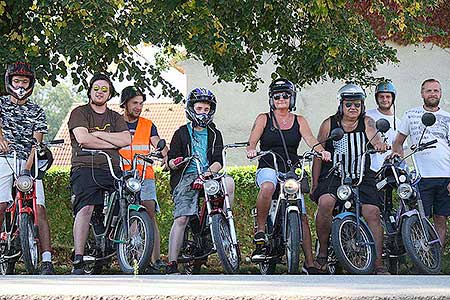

{"left": 392, "top": 79, "right": 450, "bottom": 243}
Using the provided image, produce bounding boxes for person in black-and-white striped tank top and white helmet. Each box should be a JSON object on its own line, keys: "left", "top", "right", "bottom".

{"left": 311, "top": 83, "right": 388, "bottom": 274}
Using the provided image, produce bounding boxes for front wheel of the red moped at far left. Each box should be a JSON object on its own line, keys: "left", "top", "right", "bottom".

{"left": 19, "top": 213, "right": 39, "bottom": 274}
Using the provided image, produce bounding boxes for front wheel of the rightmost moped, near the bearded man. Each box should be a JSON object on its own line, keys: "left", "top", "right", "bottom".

{"left": 402, "top": 215, "right": 442, "bottom": 274}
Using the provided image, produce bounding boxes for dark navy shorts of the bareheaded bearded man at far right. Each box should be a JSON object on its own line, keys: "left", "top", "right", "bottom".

{"left": 419, "top": 177, "right": 450, "bottom": 217}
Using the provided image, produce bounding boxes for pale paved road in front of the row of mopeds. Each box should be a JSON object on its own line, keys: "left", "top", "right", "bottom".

{"left": 0, "top": 275, "right": 450, "bottom": 300}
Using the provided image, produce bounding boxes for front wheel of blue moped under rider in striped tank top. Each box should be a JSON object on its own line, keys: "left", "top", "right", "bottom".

{"left": 331, "top": 216, "right": 376, "bottom": 275}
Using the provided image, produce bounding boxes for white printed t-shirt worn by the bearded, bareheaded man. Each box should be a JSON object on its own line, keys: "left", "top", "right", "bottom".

{"left": 398, "top": 106, "right": 450, "bottom": 178}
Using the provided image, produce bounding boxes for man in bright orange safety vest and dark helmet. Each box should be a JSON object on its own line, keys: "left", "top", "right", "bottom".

{"left": 119, "top": 86, "right": 168, "bottom": 272}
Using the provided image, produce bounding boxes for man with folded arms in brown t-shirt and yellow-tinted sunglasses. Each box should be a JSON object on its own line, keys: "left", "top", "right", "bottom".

{"left": 68, "top": 74, "right": 131, "bottom": 275}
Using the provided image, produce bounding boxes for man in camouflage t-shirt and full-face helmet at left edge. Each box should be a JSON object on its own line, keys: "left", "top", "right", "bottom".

{"left": 0, "top": 62, "right": 55, "bottom": 275}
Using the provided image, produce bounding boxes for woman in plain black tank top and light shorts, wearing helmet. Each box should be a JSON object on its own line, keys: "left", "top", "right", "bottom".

{"left": 247, "top": 78, "right": 331, "bottom": 274}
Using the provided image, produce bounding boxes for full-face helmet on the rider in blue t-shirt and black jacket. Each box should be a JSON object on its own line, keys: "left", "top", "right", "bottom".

{"left": 185, "top": 88, "right": 217, "bottom": 127}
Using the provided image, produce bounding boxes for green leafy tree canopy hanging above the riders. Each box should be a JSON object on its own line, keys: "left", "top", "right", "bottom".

{"left": 0, "top": 0, "right": 448, "bottom": 100}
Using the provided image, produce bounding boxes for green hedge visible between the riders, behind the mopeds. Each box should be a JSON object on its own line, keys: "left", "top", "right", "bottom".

{"left": 44, "top": 166, "right": 450, "bottom": 274}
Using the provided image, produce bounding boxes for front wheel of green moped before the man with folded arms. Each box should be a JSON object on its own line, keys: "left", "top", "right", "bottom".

{"left": 117, "top": 211, "right": 154, "bottom": 274}
